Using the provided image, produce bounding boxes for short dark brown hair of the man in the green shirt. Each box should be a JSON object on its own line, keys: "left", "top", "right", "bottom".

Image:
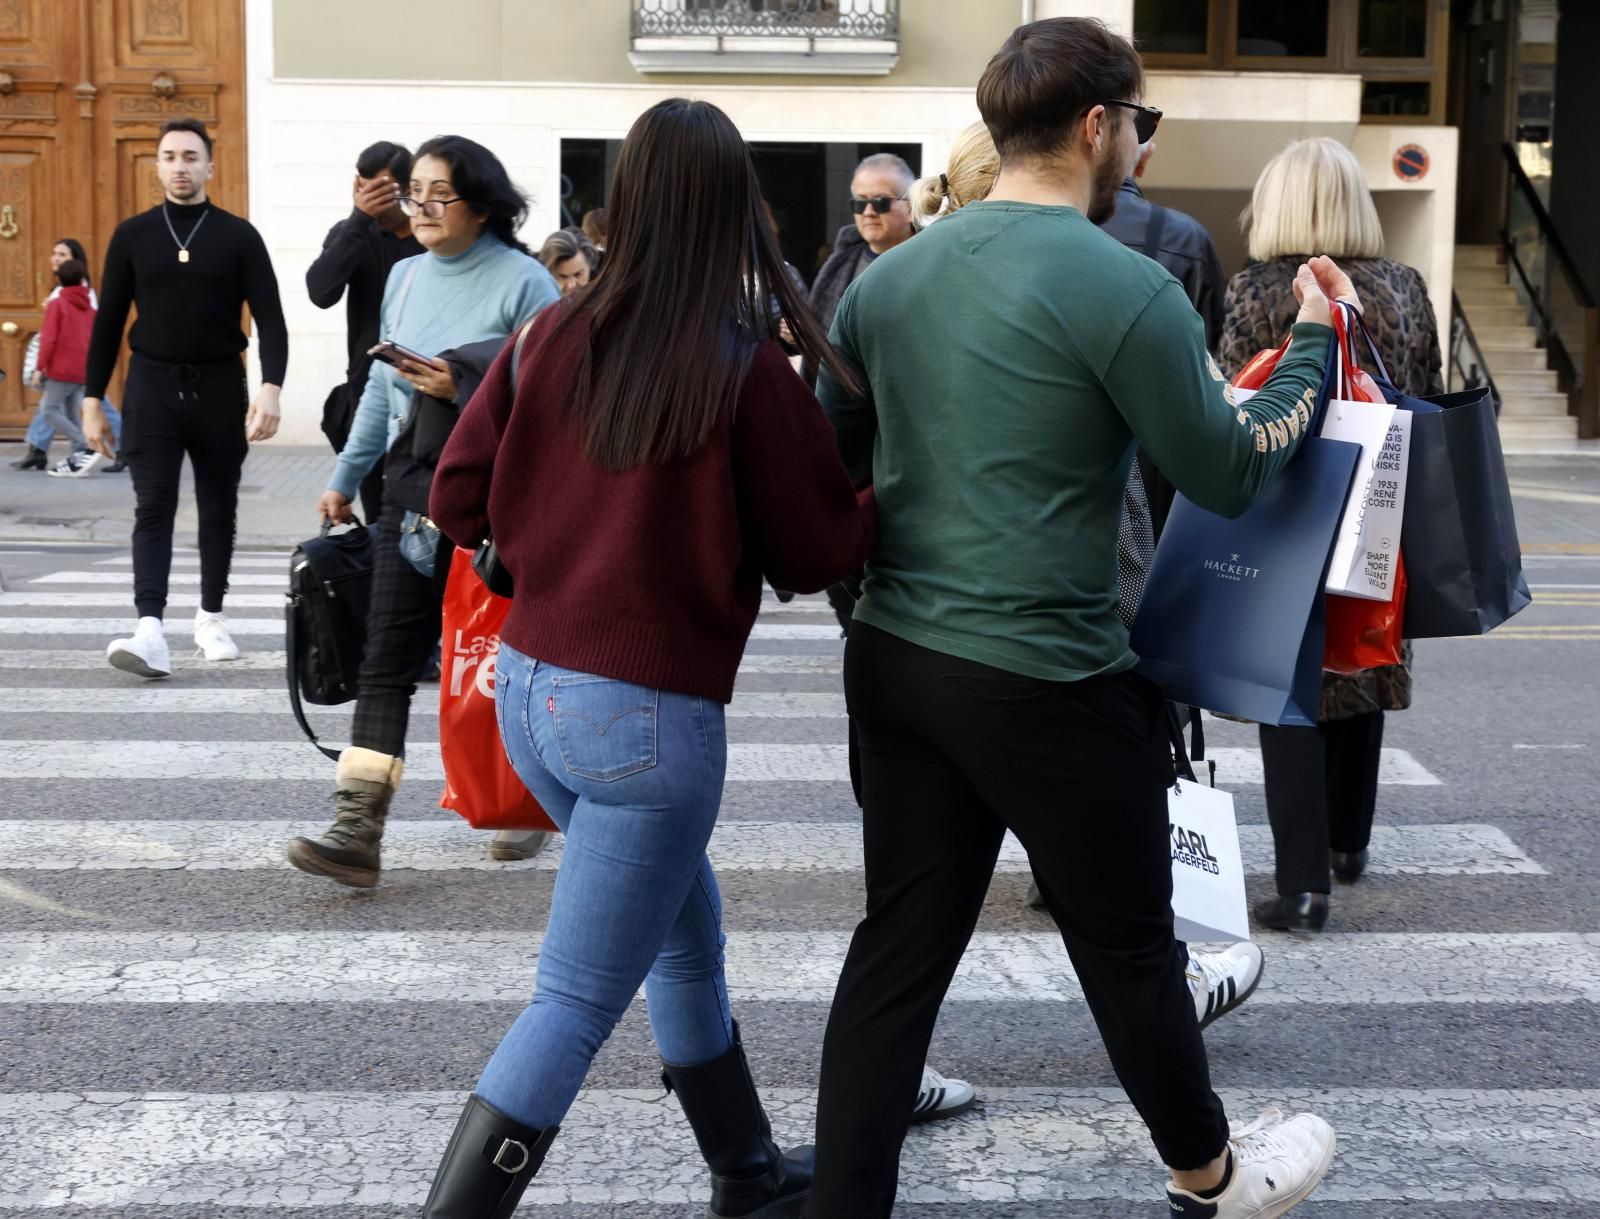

{"left": 978, "top": 18, "right": 1144, "bottom": 162}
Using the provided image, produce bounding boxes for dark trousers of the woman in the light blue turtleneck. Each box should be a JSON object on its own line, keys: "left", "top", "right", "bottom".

{"left": 350, "top": 504, "right": 454, "bottom": 757}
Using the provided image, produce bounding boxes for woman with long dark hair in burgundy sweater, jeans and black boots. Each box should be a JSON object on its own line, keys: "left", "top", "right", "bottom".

{"left": 424, "top": 99, "right": 872, "bottom": 1219}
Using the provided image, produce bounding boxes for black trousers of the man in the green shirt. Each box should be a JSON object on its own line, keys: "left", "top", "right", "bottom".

{"left": 806, "top": 622, "right": 1227, "bottom": 1219}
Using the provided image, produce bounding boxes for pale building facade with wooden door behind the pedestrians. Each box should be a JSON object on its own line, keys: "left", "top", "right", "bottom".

{"left": 0, "top": 0, "right": 1587, "bottom": 443}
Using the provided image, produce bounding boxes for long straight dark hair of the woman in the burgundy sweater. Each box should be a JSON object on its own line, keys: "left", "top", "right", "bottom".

{"left": 546, "top": 98, "right": 861, "bottom": 470}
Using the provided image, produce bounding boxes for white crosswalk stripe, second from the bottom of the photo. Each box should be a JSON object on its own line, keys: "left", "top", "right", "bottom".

{"left": 0, "top": 929, "right": 1600, "bottom": 1014}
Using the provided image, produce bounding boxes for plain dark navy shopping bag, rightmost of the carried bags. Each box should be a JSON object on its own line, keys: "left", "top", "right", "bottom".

{"left": 1355, "top": 303, "right": 1533, "bottom": 640}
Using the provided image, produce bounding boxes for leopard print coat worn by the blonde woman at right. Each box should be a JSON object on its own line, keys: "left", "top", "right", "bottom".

{"left": 1216, "top": 256, "right": 1445, "bottom": 721}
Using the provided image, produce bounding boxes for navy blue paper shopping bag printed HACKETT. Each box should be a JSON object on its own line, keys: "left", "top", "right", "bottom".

{"left": 1131, "top": 434, "right": 1362, "bottom": 726}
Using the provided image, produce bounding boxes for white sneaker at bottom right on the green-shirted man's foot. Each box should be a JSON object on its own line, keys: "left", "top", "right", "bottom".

{"left": 1166, "top": 1110, "right": 1334, "bottom": 1219}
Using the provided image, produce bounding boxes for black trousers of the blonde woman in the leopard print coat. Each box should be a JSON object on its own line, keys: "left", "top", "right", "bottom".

{"left": 1261, "top": 712, "right": 1384, "bottom": 894}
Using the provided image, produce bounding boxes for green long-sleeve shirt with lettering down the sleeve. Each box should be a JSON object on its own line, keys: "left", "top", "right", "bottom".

{"left": 818, "top": 194, "right": 1330, "bottom": 681}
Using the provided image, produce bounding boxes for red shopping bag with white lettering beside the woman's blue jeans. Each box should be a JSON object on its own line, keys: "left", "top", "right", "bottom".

{"left": 438, "top": 549, "right": 555, "bottom": 830}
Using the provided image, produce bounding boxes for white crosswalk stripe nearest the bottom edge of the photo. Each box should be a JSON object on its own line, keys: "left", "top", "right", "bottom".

{"left": 0, "top": 1088, "right": 1600, "bottom": 1219}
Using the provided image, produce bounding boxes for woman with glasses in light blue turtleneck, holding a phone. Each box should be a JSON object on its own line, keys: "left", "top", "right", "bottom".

{"left": 290, "top": 136, "right": 560, "bottom": 888}
